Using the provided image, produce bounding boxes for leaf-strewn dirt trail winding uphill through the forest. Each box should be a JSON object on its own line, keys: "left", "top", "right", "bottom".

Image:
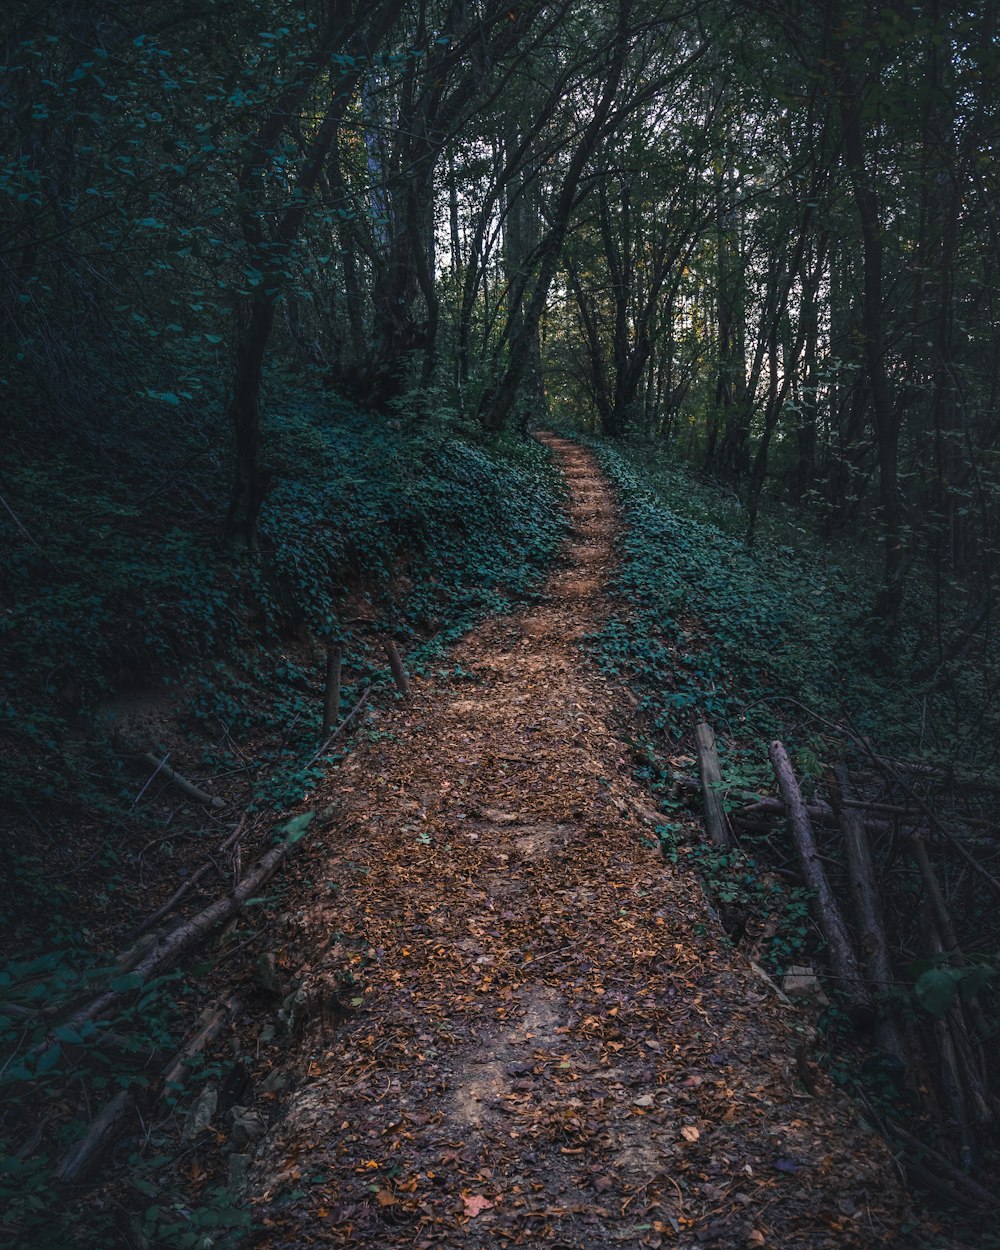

{"left": 254, "top": 436, "right": 904, "bottom": 1250}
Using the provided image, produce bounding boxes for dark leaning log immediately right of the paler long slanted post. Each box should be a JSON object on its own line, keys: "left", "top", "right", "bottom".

{"left": 829, "top": 764, "right": 910, "bottom": 1071}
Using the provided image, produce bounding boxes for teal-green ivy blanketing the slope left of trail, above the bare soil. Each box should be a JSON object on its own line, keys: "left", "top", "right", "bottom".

{"left": 0, "top": 393, "right": 560, "bottom": 850}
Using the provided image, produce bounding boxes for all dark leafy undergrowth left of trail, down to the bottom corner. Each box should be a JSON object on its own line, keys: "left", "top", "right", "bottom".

{"left": 0, "top": 379, "right": 564, "bottom": 1250}
